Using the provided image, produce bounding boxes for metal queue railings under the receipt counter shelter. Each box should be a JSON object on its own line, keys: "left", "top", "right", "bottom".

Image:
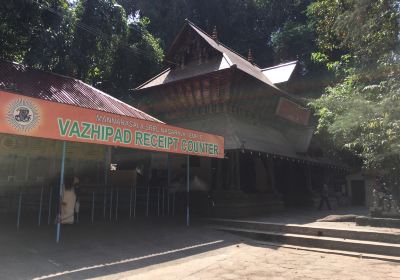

{"left": 0, "top": 184, "right": 176, "bottom": 230}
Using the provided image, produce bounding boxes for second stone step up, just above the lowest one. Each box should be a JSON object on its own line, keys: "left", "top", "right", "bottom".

{"left": 208, "top": 219, "right": 400, "bottom": 244}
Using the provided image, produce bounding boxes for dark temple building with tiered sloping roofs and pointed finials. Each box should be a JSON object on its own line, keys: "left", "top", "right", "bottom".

{"left": 131, "top": 21, "right": 345, "bottom": 216}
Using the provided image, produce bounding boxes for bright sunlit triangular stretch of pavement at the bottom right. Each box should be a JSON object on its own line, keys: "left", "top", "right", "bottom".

{"left": 94, "top": 243, "right": 400, "bottom": 280}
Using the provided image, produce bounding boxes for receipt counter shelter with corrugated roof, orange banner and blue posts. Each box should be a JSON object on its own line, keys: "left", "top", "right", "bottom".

{"left": 0, "top": 62, "right": 224, "bottom": 242}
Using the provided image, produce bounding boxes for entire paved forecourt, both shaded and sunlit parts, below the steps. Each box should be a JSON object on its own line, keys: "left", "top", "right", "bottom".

{"left": 0, "top": 208, "right": 400, "bottom": 280}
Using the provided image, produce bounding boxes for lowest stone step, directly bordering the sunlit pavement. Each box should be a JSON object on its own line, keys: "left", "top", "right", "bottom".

{"left": 214, "top": 226, "right": 400, "bottom": 257}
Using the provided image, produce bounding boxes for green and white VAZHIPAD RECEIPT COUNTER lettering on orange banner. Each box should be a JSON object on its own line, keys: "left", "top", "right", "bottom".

{"left": 57, "top": 118, "right": 219, "bottom": 155}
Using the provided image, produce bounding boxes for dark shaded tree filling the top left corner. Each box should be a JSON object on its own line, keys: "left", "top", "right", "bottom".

{"left": 0, "top": 0, "right": 73, "bottom": 70}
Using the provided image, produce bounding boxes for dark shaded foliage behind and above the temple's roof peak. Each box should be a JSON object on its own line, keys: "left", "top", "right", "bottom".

{"left": 134, "top": 0, "right": 313, "bottom": 66}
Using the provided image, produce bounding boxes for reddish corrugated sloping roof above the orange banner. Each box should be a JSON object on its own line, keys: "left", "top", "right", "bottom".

{"left": 0, "top": 60, "right": 161, "bottom": 123}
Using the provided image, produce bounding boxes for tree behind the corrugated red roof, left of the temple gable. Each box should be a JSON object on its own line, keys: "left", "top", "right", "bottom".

{"left": 71, "top": 0, "right": 163, "bottom": 99}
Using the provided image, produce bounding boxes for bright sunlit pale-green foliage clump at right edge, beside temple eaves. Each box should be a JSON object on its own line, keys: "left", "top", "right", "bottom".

{"left": 312, "top": 61, "right": 400, "bottom": 171}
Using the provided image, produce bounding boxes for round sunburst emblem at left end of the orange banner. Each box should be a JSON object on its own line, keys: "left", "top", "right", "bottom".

{"left": 7, "top": 99, "right": 39, "bottom": 132}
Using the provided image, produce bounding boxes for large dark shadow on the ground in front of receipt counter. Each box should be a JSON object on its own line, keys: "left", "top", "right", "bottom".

{"left": 0, "top": 219, "right": 239, "bottom": 280}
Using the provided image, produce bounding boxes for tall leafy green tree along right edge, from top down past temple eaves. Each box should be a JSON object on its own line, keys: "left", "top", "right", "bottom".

{"left": 308, "top": 0, "right": 400, "bottom": 199}
